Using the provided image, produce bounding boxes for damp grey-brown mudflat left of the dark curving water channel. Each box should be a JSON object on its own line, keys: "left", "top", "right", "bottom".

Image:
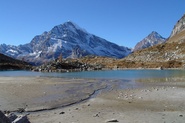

{"left": 0, "top": 77, "right": 106, "bottom": 111}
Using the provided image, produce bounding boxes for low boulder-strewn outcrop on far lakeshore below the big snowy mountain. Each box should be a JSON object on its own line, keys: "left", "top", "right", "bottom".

{"left": 33, "top": 55, "right": 117, "bottom": 72}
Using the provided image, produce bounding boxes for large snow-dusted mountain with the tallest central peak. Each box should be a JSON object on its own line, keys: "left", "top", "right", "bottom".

{"left": 0, "top": 21, "right": 131, "bottom": 64}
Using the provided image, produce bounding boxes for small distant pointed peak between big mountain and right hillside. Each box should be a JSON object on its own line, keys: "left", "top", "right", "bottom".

{"left": 134, "top": 31, "right": 166, "bottom": 51}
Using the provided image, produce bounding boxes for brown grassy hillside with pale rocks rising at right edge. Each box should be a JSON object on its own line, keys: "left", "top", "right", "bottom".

{"left": 114, "top": 15, "right": 185, "bottom": 68}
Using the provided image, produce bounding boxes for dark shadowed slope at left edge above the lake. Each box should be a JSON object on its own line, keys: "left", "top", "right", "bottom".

{"left": 0, "top": 53, "right": 31, "bottom": 70}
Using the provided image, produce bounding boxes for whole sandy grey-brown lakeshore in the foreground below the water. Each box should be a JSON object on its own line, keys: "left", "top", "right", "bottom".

{"left": 0, "top": 77, "right": 185, "bottom": 123}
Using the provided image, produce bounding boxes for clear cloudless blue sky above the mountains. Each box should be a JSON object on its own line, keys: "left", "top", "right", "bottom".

{"left": 0, "top": 0, "right": 185, "bottom": 47}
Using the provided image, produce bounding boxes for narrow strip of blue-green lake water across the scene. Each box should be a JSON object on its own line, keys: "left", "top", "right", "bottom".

{"left": 0, "top": 70, "right": 185, "bottom": 80}
